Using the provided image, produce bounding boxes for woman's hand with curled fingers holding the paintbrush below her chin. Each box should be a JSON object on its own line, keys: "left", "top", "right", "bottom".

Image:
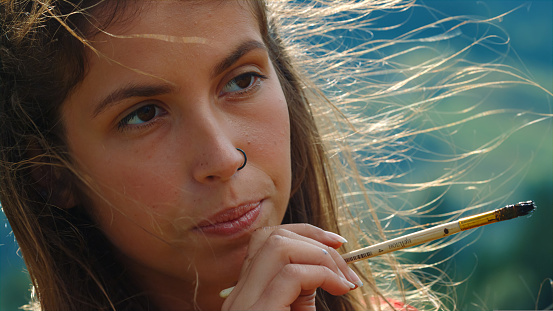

{"left": 222, "top": 224, "right": 362, "bottom": 311}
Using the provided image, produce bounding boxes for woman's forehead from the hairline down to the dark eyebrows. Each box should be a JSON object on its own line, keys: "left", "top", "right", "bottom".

{"left": 70, "top": 0, "right": 263, "bottom": 101}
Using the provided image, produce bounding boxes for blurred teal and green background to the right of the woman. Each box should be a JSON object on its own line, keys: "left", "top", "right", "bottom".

{"left": 368, "top": 1, "right": 553, "bottom": 310}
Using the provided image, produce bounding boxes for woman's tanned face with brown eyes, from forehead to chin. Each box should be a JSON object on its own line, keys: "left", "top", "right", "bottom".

{"left": 62, "top": 1, "right": 291, "bottom": 305}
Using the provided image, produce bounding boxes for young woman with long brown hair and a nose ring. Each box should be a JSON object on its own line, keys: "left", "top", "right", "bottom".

{"left": 0, "top": 1, "right": 548, "bottom": 310}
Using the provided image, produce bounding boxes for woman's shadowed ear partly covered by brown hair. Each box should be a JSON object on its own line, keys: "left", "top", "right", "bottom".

{"left": 27, "top": 143, "right": 78, "bottom": 209}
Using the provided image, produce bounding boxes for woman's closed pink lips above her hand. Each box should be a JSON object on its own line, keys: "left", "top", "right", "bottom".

{"left": 194, "top": 201, "right": 261, "bottom": 236}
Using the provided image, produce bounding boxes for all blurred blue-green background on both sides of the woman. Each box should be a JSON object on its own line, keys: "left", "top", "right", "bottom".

{"left": 0, "top": 0, "right": 553, "bottom": 311}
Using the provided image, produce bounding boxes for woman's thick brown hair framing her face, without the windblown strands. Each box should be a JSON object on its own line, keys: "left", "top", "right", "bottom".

{"left": 0, "top": 1, "right": 360, "bottom": 310}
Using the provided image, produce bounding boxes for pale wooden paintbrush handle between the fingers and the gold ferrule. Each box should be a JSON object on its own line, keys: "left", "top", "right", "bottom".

{"left": 342, "top": 221, "right": 462, "bottom": 264}
